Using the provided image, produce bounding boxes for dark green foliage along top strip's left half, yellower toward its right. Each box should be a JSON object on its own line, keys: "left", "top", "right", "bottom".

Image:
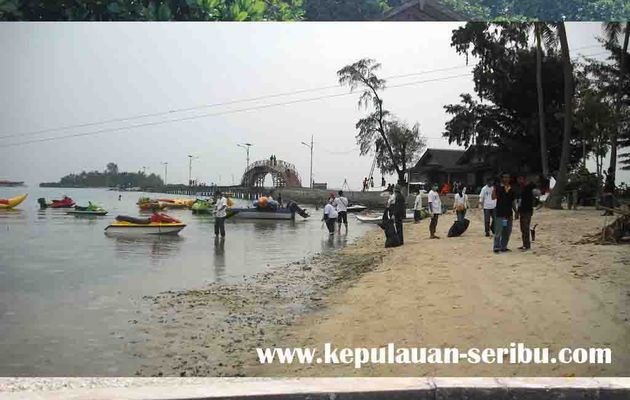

{"left": 0, "top": 0, "right": 303, "bottom": 21}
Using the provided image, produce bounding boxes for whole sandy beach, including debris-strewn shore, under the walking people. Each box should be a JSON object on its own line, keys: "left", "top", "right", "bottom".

{"left": 129, "top": 209, "right": 630, "bottom": 376}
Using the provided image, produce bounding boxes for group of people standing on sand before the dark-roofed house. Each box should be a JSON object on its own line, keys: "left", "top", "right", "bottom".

{"left": 414, "top": 173, "right": 541, "bottom": 253}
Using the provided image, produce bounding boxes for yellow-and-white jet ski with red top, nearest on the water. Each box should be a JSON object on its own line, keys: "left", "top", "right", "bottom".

{"left": 105, "top": 213, "right": 186, "bottom": 235}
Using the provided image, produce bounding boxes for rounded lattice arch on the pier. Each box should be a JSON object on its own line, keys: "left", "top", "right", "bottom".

{"left": 241, "top": 160, "right": 302, "bottom": 187}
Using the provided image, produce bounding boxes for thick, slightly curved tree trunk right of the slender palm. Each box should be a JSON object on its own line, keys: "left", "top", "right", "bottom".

{"left": 549, "top": 22, "right": 573, "bottom": 209}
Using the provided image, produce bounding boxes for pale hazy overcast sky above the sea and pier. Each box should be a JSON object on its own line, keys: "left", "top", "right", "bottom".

{"left": 0, "top": 22, "right": 630, "bottom": 189}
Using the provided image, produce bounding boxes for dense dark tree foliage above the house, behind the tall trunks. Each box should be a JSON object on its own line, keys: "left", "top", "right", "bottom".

{"left": 444, "top": 23, "right": 582, "bottom": 172}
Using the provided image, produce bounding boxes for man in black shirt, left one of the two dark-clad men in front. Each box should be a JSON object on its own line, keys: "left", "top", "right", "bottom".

{"left": 492, "top": 173, "right": 518, "bottom": 253}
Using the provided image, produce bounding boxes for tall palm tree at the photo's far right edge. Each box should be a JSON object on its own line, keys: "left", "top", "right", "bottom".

{"left": 604, "top": 22, "right": 630, "bottom": 183}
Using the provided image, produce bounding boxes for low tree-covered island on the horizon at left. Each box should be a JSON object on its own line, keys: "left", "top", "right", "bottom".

{"left": 39, "top": 162, "right": 164, "bottom": 188}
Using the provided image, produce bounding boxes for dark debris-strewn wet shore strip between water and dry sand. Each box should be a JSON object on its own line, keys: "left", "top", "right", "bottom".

{"left": 126, "top": 229, "right": 388, "bottom": 377}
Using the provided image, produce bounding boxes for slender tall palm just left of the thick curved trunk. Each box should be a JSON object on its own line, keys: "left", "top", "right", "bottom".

{"left": 534, "top": 22, "right": 556, "bottom": 177}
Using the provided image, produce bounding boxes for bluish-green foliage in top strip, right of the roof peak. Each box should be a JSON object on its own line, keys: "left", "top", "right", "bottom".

{"left": 443, "top": 0, "right": 630, "bottom": 22}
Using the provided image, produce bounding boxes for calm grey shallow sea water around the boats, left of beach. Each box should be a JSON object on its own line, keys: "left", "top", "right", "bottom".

{"left": 0, "top": 188, "right": 372, "bottom": 375}
